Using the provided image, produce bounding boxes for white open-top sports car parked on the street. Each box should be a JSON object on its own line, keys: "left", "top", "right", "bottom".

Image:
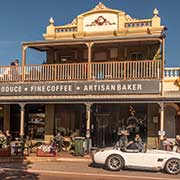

{"left": 92, "top": 147, "right": 180, "bottom": 174}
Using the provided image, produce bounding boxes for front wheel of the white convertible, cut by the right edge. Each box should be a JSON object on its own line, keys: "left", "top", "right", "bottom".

{"left": 164, "top": 158, "right": 180, "bottom": 174}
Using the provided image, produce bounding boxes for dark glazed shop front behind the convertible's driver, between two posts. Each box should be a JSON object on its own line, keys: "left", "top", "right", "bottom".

{"left": 91, "top": 104, "right": 147, "bottom": 147}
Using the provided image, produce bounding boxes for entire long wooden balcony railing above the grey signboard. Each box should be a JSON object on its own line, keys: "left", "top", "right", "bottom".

{"left": 0, "top": 60, "right": 161, "bottom": 83}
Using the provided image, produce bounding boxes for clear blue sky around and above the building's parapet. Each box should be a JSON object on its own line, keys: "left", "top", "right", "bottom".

{"left": 0, "top": 0, "right": 180, "bottom": 67}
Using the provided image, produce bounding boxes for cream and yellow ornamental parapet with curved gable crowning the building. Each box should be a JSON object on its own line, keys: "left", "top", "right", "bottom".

{"left": 44, "top": 3, "right": 165, "bottom": 40}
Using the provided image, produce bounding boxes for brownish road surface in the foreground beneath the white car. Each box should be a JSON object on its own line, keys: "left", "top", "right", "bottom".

{"left": 0, "top": 162, "right": 180, "bottom": 180}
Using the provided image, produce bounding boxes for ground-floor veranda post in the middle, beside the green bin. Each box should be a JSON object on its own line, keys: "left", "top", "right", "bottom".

{"left": 86, "top": 103, "right": 92, "bottom": 153}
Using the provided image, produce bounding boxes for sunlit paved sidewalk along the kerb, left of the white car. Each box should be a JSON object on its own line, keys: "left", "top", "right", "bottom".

{"left": 0, "top": 152, "right": 91, "bottom": 163}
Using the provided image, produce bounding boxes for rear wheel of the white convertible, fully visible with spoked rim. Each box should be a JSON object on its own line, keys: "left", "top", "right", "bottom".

{"left": 106, "top": 154, "right": 124, "bottom": 171}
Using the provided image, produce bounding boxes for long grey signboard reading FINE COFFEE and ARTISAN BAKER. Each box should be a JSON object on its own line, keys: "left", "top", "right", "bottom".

{"left": 0, "top": 80, "right": 160, "bottom": 96}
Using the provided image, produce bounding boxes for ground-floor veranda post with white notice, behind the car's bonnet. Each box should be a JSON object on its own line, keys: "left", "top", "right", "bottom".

{"left": 159, "top": 102, "right": 165, "bottom": 149}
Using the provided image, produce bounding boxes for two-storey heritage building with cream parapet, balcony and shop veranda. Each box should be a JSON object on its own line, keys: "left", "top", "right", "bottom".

{"left": 0, "top": 3, "right": 180, "bottom": 147}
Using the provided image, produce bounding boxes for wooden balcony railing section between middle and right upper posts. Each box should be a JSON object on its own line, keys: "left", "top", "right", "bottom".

{"left": 91, "top": 60, "right": 161, "bottom": 79}
